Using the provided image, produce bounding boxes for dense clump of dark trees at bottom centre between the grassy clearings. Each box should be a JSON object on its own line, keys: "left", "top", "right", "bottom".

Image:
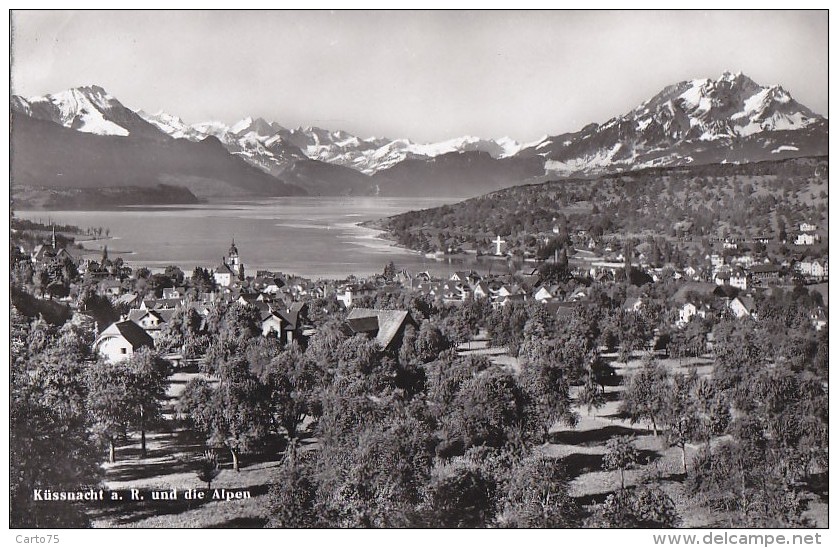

{"left": 262, "top": 328, "right": 581, "bottom": 527}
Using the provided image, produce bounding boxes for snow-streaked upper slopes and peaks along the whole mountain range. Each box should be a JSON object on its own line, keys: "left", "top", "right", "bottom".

{"left": 18, "top": 72, "right": 828, "bottom": 189}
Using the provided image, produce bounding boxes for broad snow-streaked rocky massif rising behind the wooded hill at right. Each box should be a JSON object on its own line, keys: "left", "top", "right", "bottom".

{"left": 520, "top": 72, "right": 827, "bottom": 175}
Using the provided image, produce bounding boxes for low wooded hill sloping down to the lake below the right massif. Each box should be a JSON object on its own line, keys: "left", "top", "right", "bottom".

{"left": 378, "top": 156, "right": 829, "bottom": 252}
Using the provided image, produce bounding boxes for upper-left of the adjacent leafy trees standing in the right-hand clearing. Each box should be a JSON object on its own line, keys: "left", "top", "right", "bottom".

{"left": 620, "top": 359, "right": 669, "bottom": 437}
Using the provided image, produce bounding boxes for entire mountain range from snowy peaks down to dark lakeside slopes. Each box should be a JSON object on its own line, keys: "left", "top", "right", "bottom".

{"left": 11, "top": 73, "right": 828, "bottom": 207}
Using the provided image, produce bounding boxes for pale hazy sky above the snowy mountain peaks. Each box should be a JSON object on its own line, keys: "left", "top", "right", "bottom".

{"left": 12, "top": 10, "right": 828, "bottom": 141}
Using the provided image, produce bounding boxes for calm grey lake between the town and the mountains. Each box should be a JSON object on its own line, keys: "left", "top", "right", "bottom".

{"left": 15, "top": 197, "right": 506, "bottom": 279}
